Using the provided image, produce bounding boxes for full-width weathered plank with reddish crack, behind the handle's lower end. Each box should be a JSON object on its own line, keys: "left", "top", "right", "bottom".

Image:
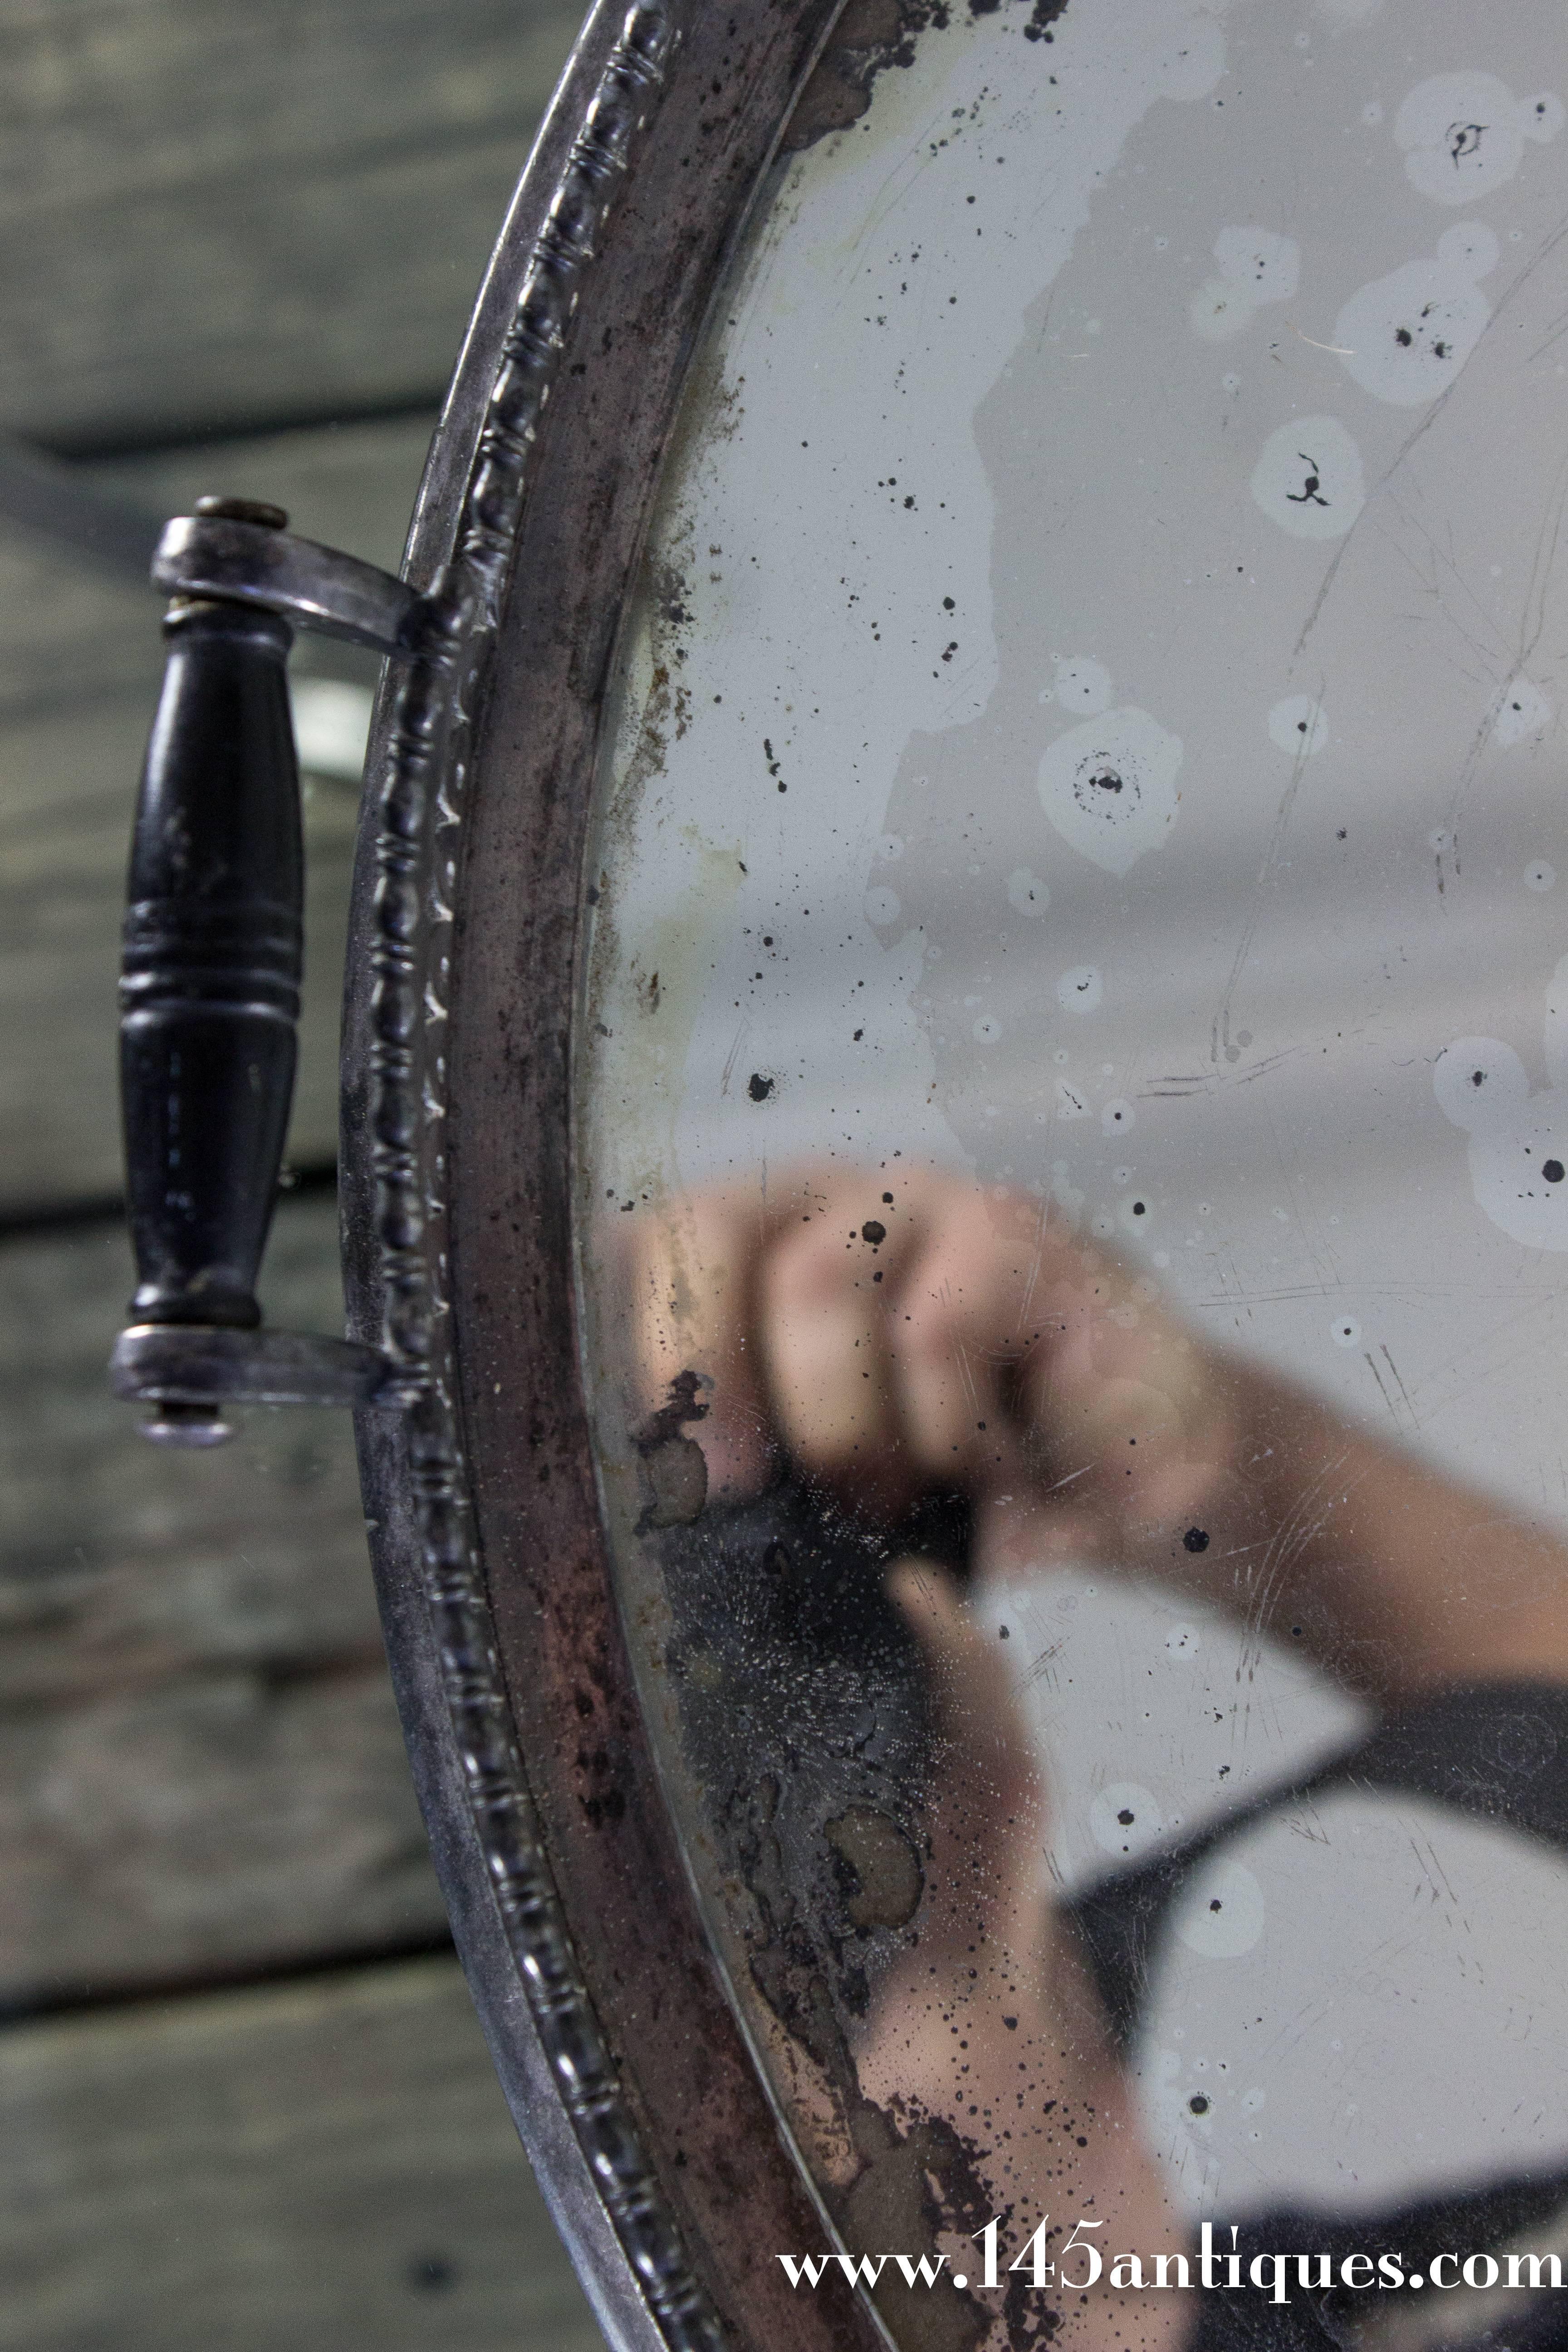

{"left": 0, "top": 1200, "right": 444, "bottom": 2004}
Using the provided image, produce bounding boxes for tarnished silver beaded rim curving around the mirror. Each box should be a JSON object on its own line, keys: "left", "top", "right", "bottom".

{"left": 343, "top": 0, "right": 898, "bottom": 2352}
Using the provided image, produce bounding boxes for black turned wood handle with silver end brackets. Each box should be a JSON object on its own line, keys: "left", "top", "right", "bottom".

{"left": 111, "top": 499, "right": 421, "bottom": 1444}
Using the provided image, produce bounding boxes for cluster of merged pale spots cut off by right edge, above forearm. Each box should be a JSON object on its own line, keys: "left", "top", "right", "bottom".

{"left": 1431, "top": 974, "right": 1568, "bottom": 1249}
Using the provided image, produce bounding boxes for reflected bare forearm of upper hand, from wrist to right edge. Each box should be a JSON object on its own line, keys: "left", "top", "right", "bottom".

{"left": 1128, "top": 1364, "right": 1568, "bottom": 1696}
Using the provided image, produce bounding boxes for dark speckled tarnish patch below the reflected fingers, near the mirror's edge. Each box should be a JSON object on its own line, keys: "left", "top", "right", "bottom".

{"left": 647, "top": 1486, "right": 992, "bottom": 2352}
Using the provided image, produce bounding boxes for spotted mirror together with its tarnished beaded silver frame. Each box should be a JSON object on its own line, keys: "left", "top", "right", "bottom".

{"left": 113, "top": 0, "right": 1568, "bottom": 2352}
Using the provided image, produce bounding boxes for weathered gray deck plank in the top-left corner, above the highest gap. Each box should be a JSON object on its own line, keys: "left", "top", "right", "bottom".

{"left": 0, "top": 0, "right": 581, "bottom": 449}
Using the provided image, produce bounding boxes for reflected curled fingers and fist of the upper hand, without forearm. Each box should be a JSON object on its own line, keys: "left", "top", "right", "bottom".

{"left": 635, "top": 1171, "right": 1234, "bottom": 1559}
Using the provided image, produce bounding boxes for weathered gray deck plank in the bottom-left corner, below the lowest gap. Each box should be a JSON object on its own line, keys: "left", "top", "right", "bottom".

{"left": 0, "top": 1961, "right": 602, "bottom": 2352}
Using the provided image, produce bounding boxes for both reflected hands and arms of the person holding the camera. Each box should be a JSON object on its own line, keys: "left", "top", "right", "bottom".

{"left": 630, "top": 1169, "right": 1568, "bottom": 2352}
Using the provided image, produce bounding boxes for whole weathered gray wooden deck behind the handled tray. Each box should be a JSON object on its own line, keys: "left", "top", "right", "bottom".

{"left": 0, "top": 0, "right": 620, "bottom": 2352}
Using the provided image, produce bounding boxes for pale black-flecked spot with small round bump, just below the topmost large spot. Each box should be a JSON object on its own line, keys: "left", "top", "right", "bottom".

{"left": 1328, "top": 221, "right": 1498, "bottom": 409}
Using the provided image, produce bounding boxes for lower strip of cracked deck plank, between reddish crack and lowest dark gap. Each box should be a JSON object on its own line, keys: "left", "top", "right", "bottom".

{"left": 0, "top": 1665, "right": 444, "bottom": 2011}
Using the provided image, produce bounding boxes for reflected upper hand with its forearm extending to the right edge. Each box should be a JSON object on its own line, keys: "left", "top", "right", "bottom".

{"left": 630, "top": 1166, "right": 1568, "bottom": 1696}
